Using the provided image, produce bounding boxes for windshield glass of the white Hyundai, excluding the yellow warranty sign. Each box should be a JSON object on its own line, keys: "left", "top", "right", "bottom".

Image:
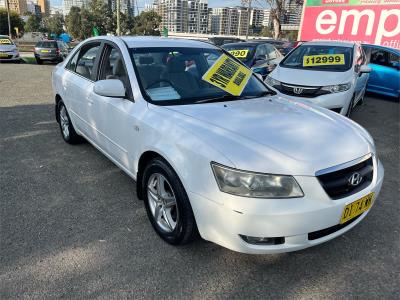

{"left": 130, "top": 47, "right": 270, "bottom": 105}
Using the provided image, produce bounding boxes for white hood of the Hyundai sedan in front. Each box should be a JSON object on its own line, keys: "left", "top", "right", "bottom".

{"left": 161, "top": 96, "right": 374, "bottom": 176}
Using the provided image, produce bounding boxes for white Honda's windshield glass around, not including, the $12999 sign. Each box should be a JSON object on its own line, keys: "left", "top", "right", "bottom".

{"left": 280, "top": 44, "right": 353, "bottom": 72}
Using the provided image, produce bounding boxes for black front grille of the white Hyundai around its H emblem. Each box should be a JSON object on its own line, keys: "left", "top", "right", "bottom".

{"left": 317, "top": 157, "right": 374, "bottom": 200}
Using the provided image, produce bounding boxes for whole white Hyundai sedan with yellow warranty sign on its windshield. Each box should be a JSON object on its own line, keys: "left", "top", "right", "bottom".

{"left": 52, "top": 36, "right": 384, "bottom": 254}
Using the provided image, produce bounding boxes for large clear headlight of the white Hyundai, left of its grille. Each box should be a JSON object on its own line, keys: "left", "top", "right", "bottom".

{"left": 211, "top": 163, "right": 304, "bottom": 198}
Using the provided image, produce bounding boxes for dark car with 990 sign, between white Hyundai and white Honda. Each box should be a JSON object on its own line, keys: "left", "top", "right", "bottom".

{"left": 221, "top": 41, "right": 283, "bottom": 79}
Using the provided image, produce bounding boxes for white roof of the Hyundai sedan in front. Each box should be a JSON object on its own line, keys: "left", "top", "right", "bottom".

{"left": 119, "top": 36, "right": 218, "bottom": 49}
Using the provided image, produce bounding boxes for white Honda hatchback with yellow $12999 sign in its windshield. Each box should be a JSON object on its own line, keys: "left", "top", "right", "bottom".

{"left": 265, "top": 41, "right": 371, "bottom": 117}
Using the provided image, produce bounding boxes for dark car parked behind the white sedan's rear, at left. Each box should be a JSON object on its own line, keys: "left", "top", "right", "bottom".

{"left": 34, "top": 40, "right": 69, "bottom": 65}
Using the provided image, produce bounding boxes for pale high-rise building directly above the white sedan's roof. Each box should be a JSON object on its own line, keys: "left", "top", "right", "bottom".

{"left": 152, "top": 0, "right": 208, "bottom": 33}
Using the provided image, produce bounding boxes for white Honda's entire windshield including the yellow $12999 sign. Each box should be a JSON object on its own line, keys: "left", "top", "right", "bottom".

{"left": 280, "top": 44, "right": 353, "bottom": 72}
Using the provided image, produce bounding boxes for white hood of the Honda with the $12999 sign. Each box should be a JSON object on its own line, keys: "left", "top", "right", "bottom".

{"left": 270, "top": 66, "right": 353, "bottom": 86}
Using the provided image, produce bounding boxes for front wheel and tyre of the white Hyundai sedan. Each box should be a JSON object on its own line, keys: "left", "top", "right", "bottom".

{"left": 142, "top": 158, "right": 198, "bottom": 245}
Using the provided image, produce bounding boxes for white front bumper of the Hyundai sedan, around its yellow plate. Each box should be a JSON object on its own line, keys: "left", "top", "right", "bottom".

{"left": 189, "top": 158, "right": 384, "bottom": 254}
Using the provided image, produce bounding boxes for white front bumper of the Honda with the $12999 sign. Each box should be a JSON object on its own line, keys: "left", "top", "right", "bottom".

{"left": 268, "top": 86, "right": 354, "bottom": 115}
